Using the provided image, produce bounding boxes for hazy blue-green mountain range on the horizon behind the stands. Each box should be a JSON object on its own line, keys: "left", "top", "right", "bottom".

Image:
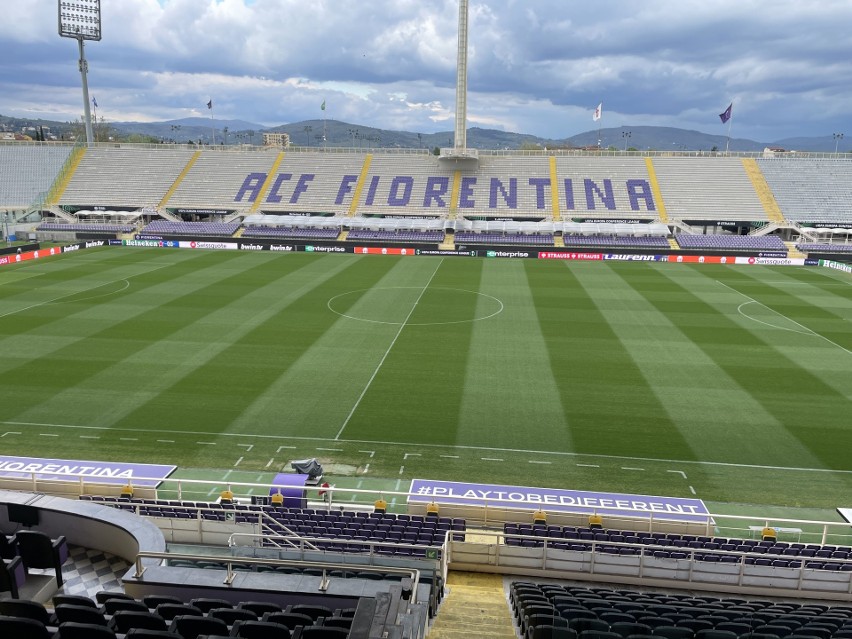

{"left": 0, "top": 115, "right": 852, "bottom": 153}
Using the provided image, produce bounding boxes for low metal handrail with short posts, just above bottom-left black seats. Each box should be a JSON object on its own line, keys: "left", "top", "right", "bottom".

{"left": 133, "top": 551, "right": 420, "bottom": 597}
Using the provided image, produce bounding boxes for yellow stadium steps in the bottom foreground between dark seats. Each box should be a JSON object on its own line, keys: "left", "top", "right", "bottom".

{"left": 428, "top": 571, "right": 518, "bottom": 639}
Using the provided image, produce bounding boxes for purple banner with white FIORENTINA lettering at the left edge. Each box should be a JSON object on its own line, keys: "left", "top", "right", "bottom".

{"left": 0, "top": 455, "right": 177, "bottom": 488}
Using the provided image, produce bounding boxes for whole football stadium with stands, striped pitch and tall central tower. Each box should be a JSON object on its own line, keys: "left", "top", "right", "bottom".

{"left": 0, "top": 2, "right": 852, "bottom": 639}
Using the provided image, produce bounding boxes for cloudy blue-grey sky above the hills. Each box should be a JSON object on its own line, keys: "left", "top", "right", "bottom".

{"left": 0, "top": 0, "right": 852, "bottom": 142}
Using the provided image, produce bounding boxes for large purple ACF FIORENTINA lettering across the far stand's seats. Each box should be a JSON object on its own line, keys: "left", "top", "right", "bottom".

{"left": 234, "top": 173, "right": 657, "bottom": 212}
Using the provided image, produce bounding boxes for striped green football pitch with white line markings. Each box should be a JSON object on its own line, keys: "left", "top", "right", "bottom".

{"left": 0, "top": 248, "right": 852, "bottom": 508}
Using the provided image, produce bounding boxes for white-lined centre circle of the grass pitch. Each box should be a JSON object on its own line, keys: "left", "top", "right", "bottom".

{"left": 326, "top": 286, "right": 503, "bottom": 326}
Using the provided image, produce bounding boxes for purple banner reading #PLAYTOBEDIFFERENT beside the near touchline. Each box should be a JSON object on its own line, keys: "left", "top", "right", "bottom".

{"left": 408, "top": 479, "right": 709, "bottom": 523}
